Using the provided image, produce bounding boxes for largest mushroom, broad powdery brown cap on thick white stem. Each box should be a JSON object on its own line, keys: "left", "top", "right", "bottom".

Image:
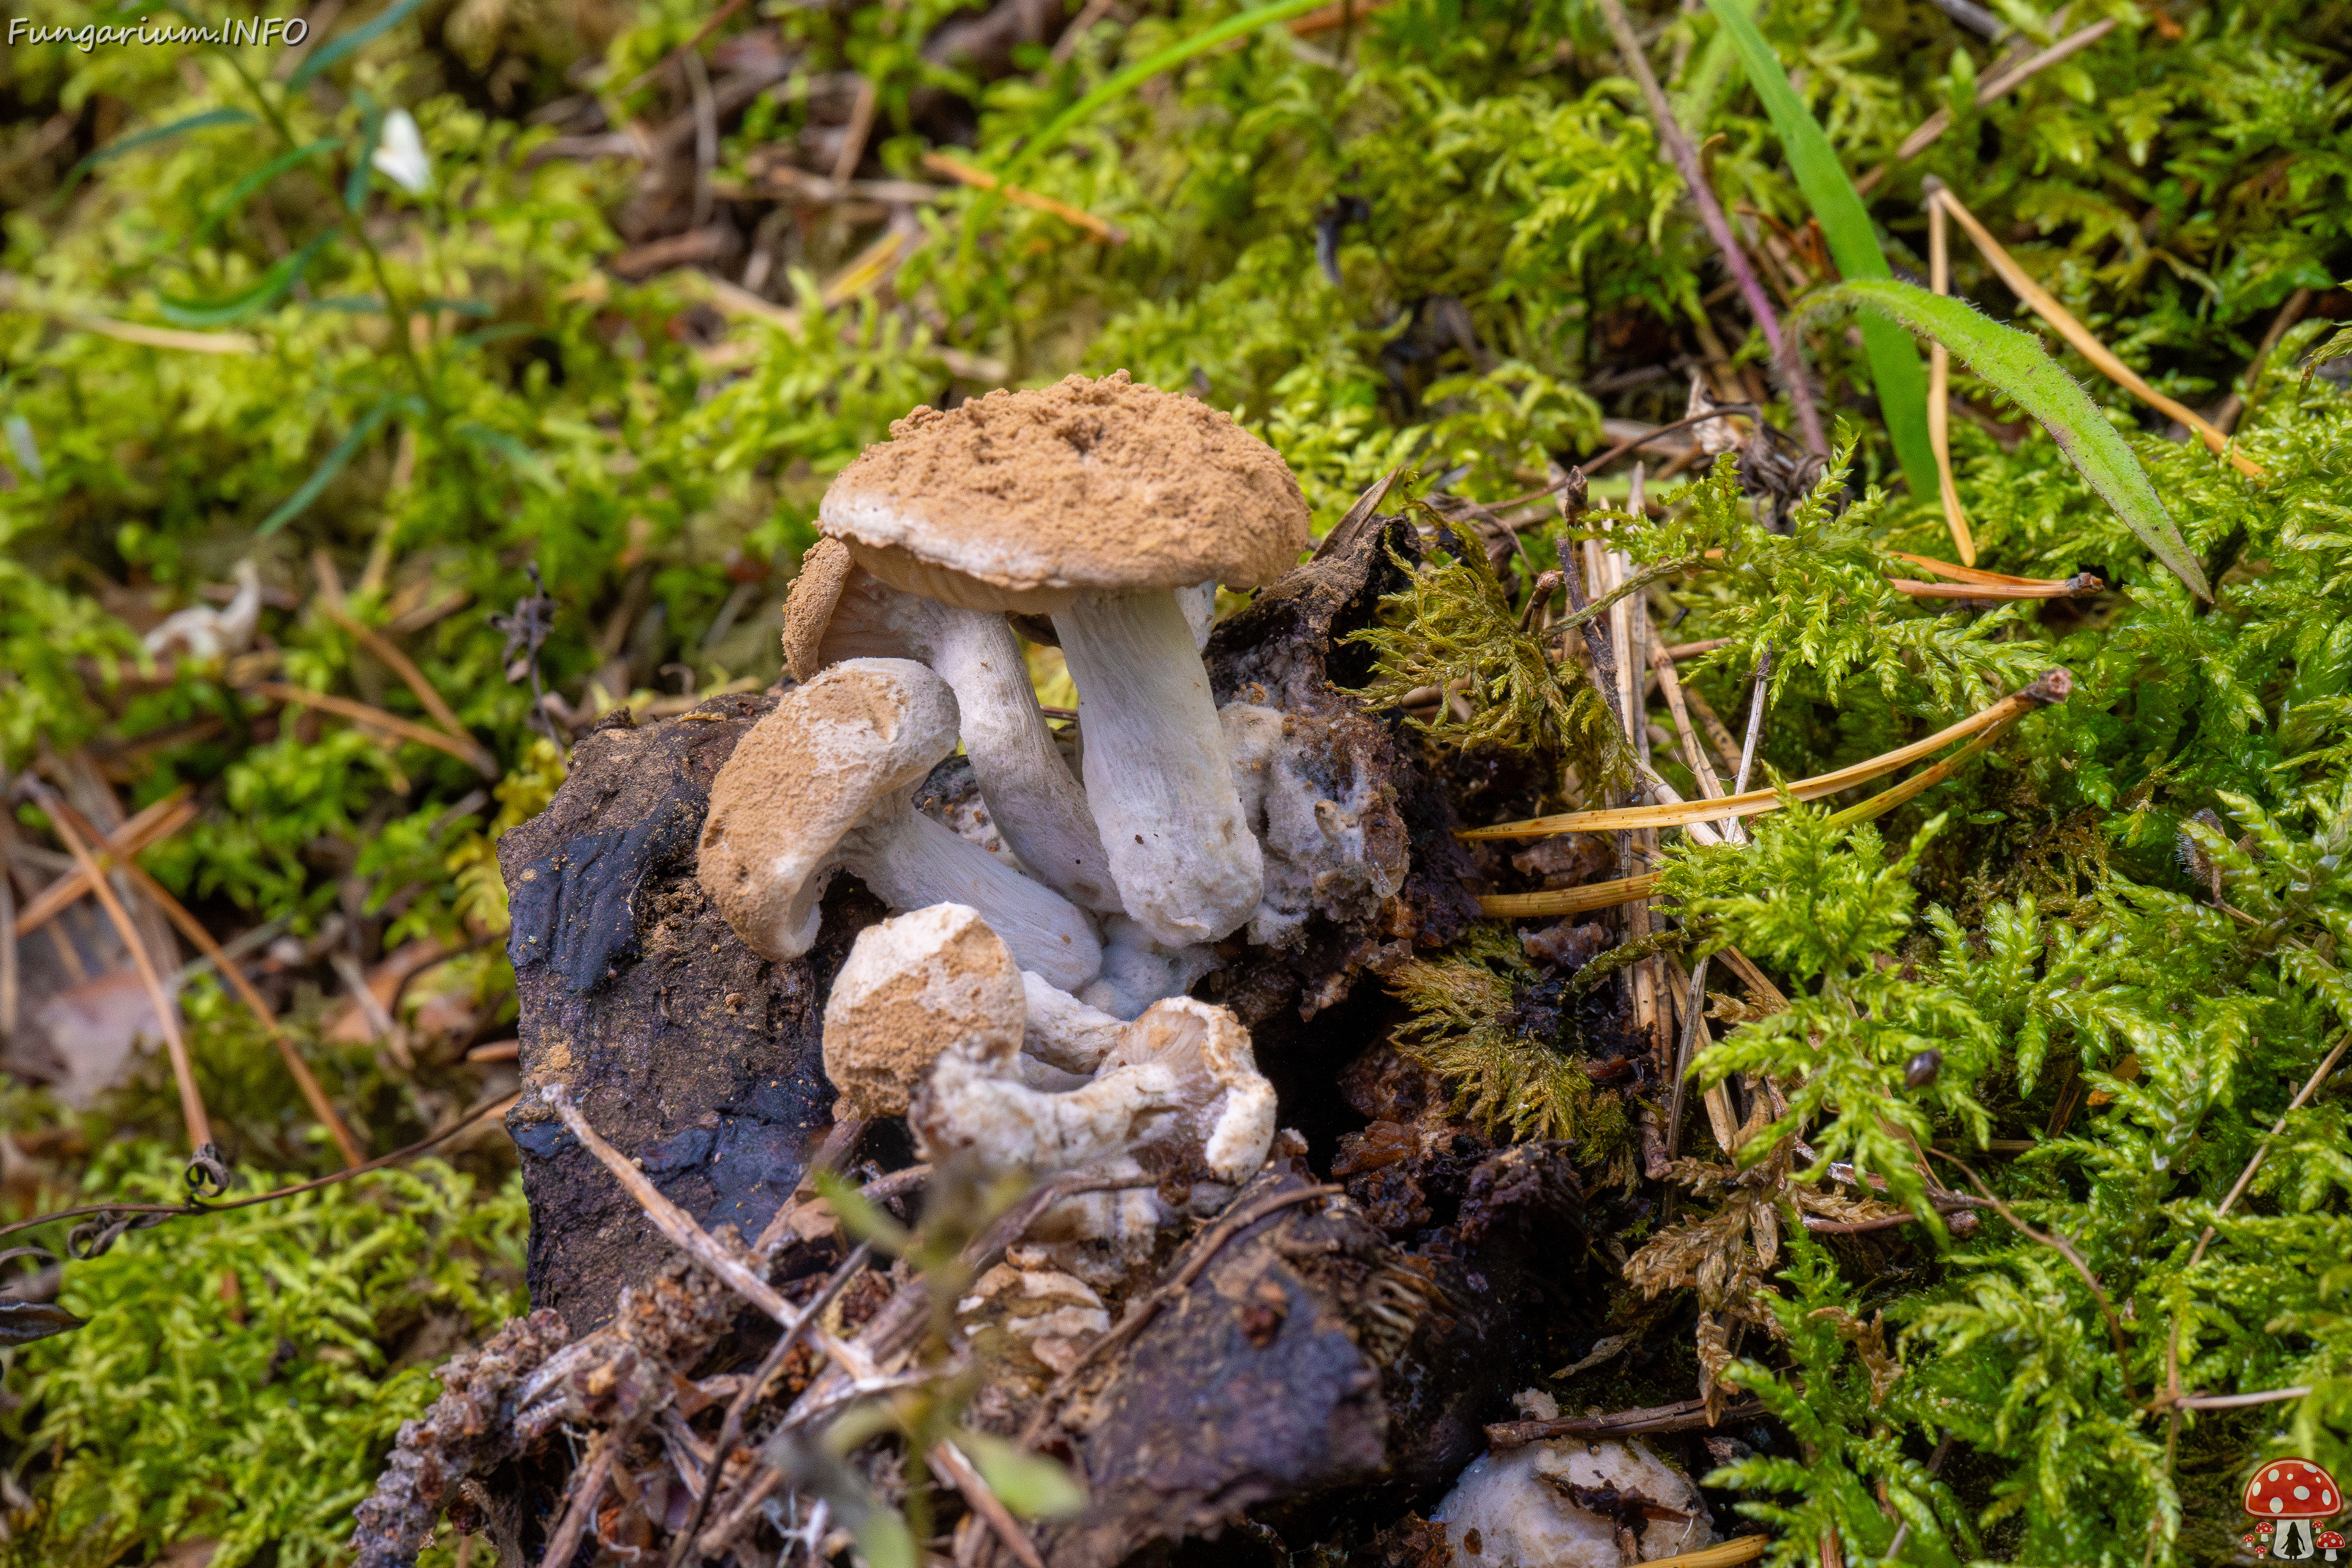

{"left": 818, "top": 371, "right": 1308, "bottom": 948}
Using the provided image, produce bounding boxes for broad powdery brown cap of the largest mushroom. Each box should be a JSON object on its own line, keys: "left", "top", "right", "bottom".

{"left": 818, "top": 371, "right": 1308, "bottom": 614}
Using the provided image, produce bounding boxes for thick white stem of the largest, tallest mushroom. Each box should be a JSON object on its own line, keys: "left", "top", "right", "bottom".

{"left": 1054, "top": 590, "right": 1265, "bottom": 948}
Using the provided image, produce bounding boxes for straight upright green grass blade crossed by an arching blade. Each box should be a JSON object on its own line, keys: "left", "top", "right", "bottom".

{"left": 1708, "top": 0, "right": 1938, "bottom": 499}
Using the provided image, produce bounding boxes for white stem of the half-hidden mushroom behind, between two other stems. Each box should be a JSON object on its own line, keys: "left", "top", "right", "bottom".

{"left": 927, "top": 604, "right": 1120, "bottom": 914}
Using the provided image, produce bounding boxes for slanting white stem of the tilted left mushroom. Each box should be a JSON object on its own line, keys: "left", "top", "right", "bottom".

{"left": 842, "top": 794, "right": 1103, "bottom": 987}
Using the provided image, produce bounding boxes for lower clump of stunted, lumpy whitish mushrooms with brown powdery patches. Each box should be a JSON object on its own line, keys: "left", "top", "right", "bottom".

{"left": 823, "top": 905, "right": 1275, "bottom": 1279}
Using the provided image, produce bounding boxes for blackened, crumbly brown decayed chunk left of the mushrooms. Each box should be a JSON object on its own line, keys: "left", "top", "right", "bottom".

{"left": 499, "top": 696, "right": 851, "bottom": 1330}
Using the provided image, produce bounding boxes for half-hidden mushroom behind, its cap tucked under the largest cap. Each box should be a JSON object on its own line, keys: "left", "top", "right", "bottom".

{"left": 783, "top": 538, "right": 1120, "bottom": 912}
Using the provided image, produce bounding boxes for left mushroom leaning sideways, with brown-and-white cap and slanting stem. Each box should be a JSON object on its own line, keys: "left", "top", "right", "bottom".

{"left": 696, "top": 658, "right": 1103, "bottom": 987}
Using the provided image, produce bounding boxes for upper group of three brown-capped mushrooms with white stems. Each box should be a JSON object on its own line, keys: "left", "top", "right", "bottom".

{"left": 698, "top": 371, "right": 1348, "bottom": 1035}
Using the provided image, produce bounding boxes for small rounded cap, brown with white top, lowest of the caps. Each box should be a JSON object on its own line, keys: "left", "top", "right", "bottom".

{"left": 826, "top": 903, "right": 1025, "bottom": 1117}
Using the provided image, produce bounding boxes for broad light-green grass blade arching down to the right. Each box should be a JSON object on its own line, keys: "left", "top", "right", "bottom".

{"left": 1809, "top": 277, "right": 2213, "bottom": 600}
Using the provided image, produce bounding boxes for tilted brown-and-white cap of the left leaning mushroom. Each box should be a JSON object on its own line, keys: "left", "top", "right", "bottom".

{"left": 696, "top": 658, "right": 957, "bottom": 959}
